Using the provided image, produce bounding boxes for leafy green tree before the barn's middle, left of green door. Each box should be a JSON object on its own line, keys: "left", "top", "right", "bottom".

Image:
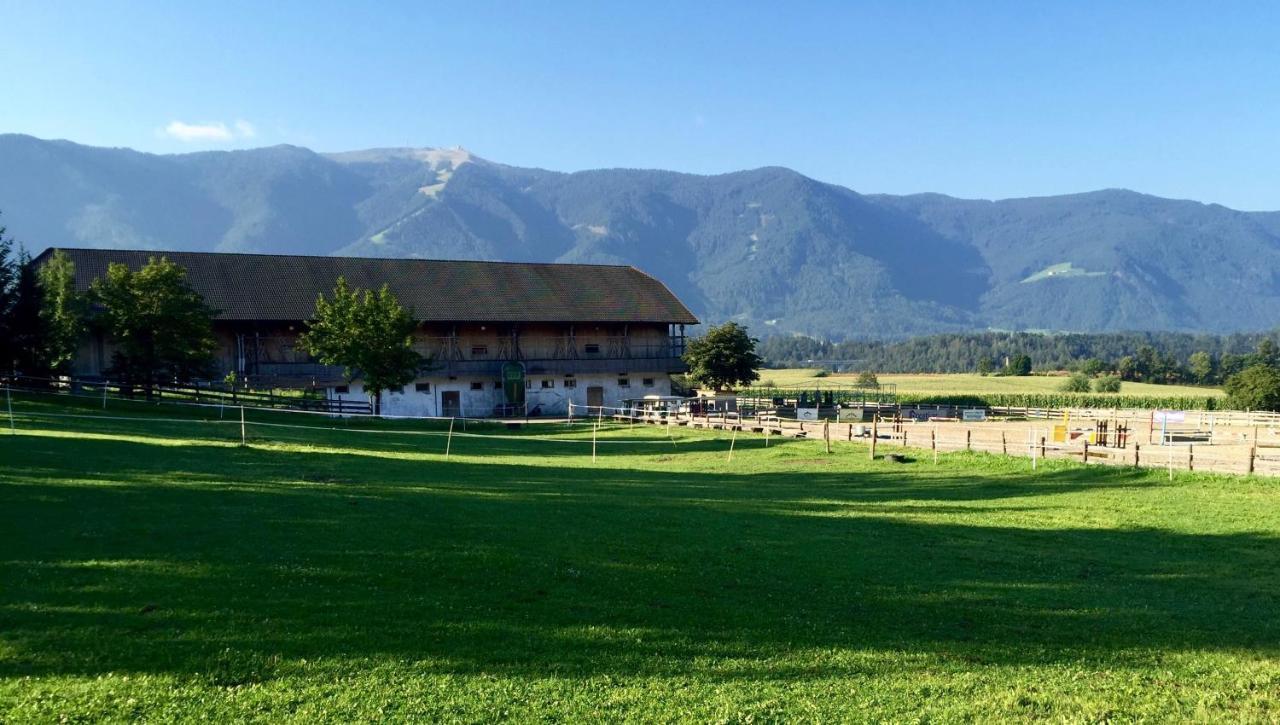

{"left": 298, "top": 277, "right": 426, "bottom": 414}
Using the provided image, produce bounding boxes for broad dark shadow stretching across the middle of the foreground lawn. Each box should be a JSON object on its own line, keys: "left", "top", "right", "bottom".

{"left": 0, "top": 437, "right": 1280, "bottom": 685}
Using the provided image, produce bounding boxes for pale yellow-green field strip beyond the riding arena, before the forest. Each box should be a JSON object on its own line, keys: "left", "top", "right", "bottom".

{"left": 760, "top": 368, "right": 1224, "bottom": 397}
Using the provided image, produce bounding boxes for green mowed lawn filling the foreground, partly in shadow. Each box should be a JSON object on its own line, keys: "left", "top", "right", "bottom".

{"left": 0, "top": 398, "right": 1280, "bottom": 722}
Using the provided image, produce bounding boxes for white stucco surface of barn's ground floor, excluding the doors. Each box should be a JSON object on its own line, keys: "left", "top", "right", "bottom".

{"left": 328, "top": 373, "right": 671, "bottom": 418}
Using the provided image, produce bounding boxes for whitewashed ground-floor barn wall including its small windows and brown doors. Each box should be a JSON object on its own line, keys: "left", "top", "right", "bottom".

{"left": 326, "top": 373, "right": 671, "bottom": 418}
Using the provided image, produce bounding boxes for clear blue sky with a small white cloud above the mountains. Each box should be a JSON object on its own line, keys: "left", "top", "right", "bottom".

{"left": 0, "top": 0, "right": 1280, "bottom": 210}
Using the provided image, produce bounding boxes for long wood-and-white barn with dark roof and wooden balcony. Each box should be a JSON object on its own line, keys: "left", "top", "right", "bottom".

{"left": 37, "top": 248, "right": 698, "bottom": 416}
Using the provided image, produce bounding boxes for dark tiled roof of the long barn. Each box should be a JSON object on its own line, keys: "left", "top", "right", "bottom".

{"left": 41, "top": 248, "right": 698, "bottom": 324}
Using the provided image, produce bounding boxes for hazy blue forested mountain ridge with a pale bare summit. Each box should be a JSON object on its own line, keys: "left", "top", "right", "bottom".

{"left": 0, "top": 134, "right": 1280, "bottom": 339}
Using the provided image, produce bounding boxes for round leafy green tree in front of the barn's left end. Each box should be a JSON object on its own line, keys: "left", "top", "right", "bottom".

{"left": 90, "top": 257, "right": 216, "bottom": 398}
